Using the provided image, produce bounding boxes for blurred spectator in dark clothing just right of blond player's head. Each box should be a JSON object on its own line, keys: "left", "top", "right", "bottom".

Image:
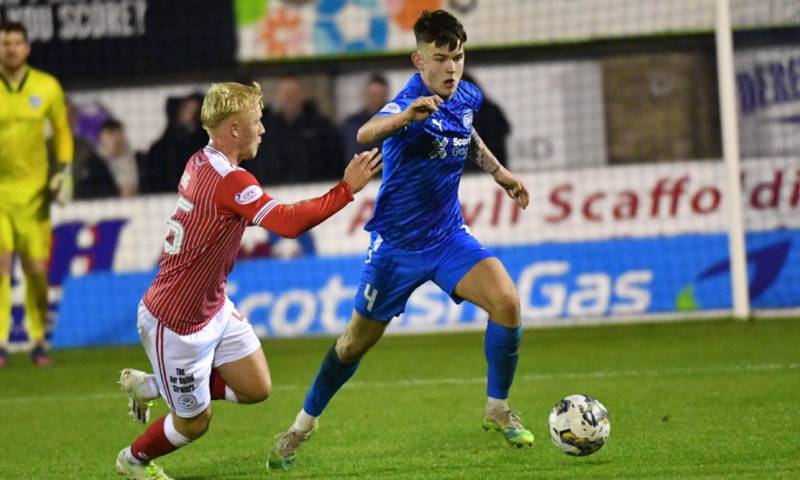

{"left": 247, "top": 76, "right": 343, "bottom": 185}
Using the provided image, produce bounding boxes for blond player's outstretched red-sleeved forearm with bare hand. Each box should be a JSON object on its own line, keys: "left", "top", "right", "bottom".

{"left": 257, "top": 148, "right": 383, "bottom": 238}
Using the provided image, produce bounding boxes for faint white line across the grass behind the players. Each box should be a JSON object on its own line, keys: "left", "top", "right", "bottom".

{"left": 0, "top": 363, "right": 800, "bottom": 405}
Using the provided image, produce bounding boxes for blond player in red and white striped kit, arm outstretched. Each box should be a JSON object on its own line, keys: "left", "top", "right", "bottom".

{"left": 116, "top": 83, "right": 382, "bottom": 480}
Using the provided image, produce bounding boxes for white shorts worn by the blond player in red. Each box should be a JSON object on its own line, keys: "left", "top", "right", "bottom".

{"left": 137, "top": 297, "right": 261, "bottom": 418}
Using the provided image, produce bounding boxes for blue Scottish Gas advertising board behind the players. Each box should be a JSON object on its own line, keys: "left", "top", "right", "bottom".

{"left": 53, "top": 230, "right": 800, "bottom": 348}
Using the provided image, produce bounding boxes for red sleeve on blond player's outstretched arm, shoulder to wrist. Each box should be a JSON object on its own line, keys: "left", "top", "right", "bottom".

{"left": 215, "top": 170, "right": 353, "bottom": 242}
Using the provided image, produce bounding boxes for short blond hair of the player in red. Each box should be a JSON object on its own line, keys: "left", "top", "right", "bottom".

{"left": 200, "top": 82, "right": 264, "bottom": 134}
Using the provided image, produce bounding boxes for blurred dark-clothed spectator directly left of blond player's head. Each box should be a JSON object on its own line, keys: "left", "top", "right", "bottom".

{"left": 140, "top": 93, "right": 208, "bottom": 193}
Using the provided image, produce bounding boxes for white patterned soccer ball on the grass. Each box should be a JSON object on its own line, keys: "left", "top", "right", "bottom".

{"left": 548, "top": 395, "right": 611, "bottom": 456}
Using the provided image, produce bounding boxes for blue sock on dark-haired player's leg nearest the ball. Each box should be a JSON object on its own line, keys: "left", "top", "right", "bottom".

{"left": 483, "top": 320, "right": 522, "bottom": 400}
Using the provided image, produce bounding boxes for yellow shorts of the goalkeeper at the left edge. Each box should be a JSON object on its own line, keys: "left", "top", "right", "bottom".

{"left": 0, "top": 208, "right": 52, "bottom": 260}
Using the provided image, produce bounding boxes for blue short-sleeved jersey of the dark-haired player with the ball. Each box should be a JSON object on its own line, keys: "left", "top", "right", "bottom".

{"left": 365, "top": 73, "right": 483, "bottom": 250}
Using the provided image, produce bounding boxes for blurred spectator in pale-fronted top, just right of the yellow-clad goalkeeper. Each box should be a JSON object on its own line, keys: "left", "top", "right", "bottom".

{"left": 75, "top": 118, "right": 139, "bottom": 199}
